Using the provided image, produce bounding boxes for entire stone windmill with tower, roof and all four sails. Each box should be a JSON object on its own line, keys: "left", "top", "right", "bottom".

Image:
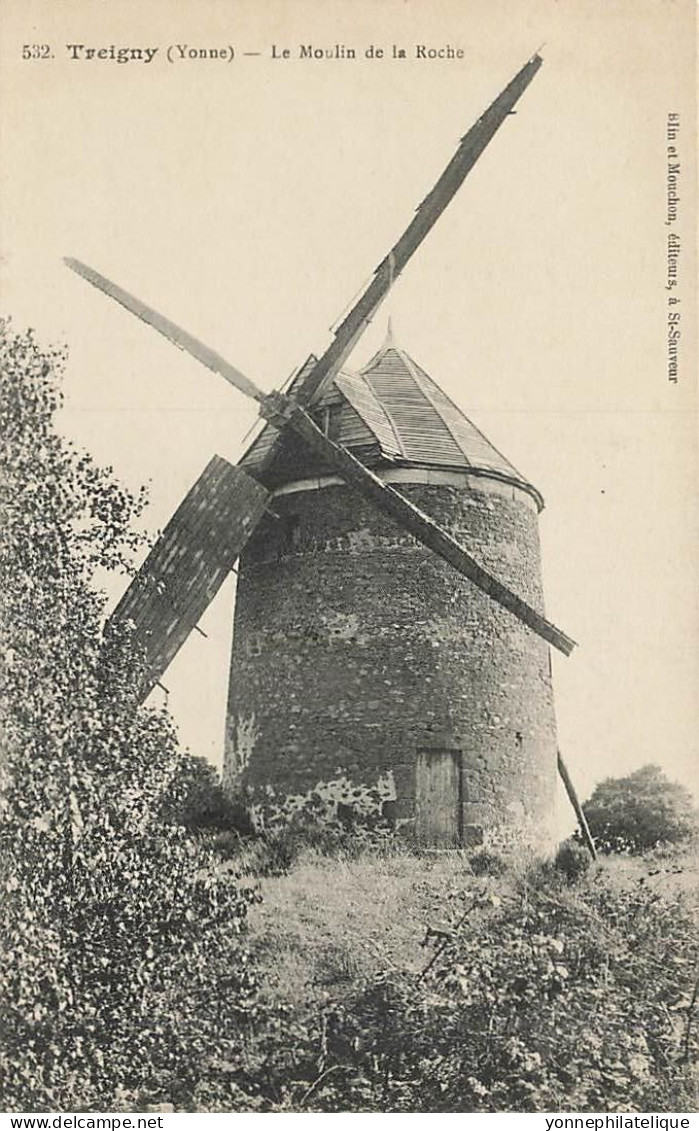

{"left": 67, "top": 55, "right": 573, "bottom": 845}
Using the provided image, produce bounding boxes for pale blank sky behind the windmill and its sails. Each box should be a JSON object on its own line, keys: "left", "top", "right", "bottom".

{"left": 0, "top": 0, "right": 699, "bottom": 814}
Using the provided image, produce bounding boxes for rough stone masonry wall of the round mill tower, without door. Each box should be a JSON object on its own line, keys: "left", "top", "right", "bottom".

{"left": 226, "top": 480, "right": 555, "bottom": 846}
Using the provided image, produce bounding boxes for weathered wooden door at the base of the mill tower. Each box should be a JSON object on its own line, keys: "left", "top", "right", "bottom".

{"left": 415, "top": 748, "right": 461, "bottom": 848}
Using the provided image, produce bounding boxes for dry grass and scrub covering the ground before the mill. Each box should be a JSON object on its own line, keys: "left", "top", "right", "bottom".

{"left": 235, "top": 843, "right": 699, "bottom": 1112}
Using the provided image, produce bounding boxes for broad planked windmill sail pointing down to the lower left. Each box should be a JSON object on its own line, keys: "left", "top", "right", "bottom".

{"left": 106, "top": 456, "right": 268, "bottom": 699}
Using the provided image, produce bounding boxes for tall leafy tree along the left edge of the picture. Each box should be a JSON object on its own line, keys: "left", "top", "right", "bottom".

{"left": 0, "top": 321, "right": 254, "bottom": 1111}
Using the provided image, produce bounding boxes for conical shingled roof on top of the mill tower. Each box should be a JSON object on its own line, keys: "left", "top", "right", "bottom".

{"left": 236, "top": 333, "right": 543, "bottom": 508}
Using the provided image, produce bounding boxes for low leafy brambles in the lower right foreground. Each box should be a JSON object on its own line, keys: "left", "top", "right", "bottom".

{"left": 238, "top": 869, "right": 699, "bottom": 1113}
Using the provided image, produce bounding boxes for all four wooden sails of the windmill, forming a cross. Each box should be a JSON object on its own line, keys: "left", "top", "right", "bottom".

{"left": 66, "top": 54, "right": 575, "bottom": 669}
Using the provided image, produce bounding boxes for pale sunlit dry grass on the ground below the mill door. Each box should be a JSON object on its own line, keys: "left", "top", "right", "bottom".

{"left": 249, "top": 847, "right": 699, "bottom": 1005}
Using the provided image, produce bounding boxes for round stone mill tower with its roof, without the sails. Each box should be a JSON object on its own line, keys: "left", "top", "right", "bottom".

{"left": 226, "top": 334, "right": 556, "bottom": 844}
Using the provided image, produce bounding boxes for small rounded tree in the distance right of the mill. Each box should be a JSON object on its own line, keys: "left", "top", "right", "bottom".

{"left": 583, "top": 766, "right": 699, "bottom": 853}
